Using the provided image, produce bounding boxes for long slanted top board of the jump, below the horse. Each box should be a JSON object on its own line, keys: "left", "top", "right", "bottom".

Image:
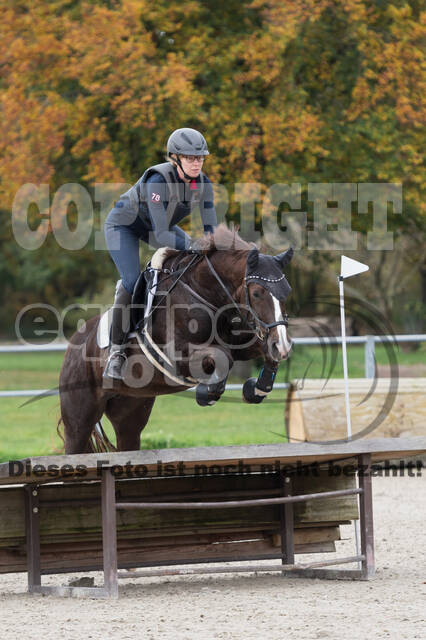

{"left": 0, "top": 436, "right": 426, "bottom": 484}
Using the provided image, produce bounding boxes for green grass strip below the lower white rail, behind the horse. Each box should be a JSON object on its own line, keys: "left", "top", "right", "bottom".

{"left": 0, "top": 390, "right": 285, "bottom": 461}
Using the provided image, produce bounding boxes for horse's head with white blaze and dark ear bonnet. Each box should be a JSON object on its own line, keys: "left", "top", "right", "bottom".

{"left": 244, "top": 248, "right": 293, "bottom": 362}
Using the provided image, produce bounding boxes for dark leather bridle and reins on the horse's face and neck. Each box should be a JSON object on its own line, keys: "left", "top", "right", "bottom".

{"left": 152, "top": 253, "right": 288, "bottom": 342}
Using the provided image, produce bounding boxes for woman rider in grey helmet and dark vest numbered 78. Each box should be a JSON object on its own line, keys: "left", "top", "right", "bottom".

{"left": 103, "top": 128, "right": 217, "bottom": 380}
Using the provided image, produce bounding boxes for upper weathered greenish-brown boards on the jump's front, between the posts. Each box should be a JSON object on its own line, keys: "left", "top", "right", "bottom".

{"left": 0, "top": 470, "right": 358, "bottom": 547}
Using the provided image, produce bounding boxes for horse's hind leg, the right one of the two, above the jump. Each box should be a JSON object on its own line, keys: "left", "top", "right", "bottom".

{"left": 105, "top": 397, "right": 155, "bottom": 451}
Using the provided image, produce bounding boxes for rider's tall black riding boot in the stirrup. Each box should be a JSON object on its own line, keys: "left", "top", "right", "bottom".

{"left": 102, "top": 280, "right": 132, "bottom": 380}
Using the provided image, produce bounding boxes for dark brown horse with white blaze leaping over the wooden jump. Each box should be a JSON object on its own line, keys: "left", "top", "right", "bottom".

{"left": 59, "top": 225, "right": 293, "bottom": 454}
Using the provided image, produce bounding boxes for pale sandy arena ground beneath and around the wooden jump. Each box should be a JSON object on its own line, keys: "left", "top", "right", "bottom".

{"left": 0, "top": 471, "right": 426, "bottom": 640}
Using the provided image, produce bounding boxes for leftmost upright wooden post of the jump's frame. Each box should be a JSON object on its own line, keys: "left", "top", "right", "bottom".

{"left": 25, "top": 484, "right": 41, "bottom": 593}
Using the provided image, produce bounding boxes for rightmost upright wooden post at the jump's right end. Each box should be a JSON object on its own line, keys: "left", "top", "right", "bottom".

{"left": 358, "top": 453, "right": 375, "bottom": 579}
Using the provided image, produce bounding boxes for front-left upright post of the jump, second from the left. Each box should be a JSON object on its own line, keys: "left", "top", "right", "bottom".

{"left": 102, "top": 469, "right": 118, "bottom": 598}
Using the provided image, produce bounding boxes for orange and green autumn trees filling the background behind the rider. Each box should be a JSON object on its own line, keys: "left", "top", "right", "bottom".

{"left": 0, "top": 0, "right": 426, "bottom": 336}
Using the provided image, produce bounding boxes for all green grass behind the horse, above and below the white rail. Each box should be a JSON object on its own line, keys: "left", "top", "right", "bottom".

{"left": 0, "top": 344, "right": 426, "bottom": 461}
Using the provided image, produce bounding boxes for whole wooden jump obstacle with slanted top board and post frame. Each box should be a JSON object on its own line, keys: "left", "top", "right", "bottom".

{"left": 0, "top": 438, "right": 426, "bottom": 598}
